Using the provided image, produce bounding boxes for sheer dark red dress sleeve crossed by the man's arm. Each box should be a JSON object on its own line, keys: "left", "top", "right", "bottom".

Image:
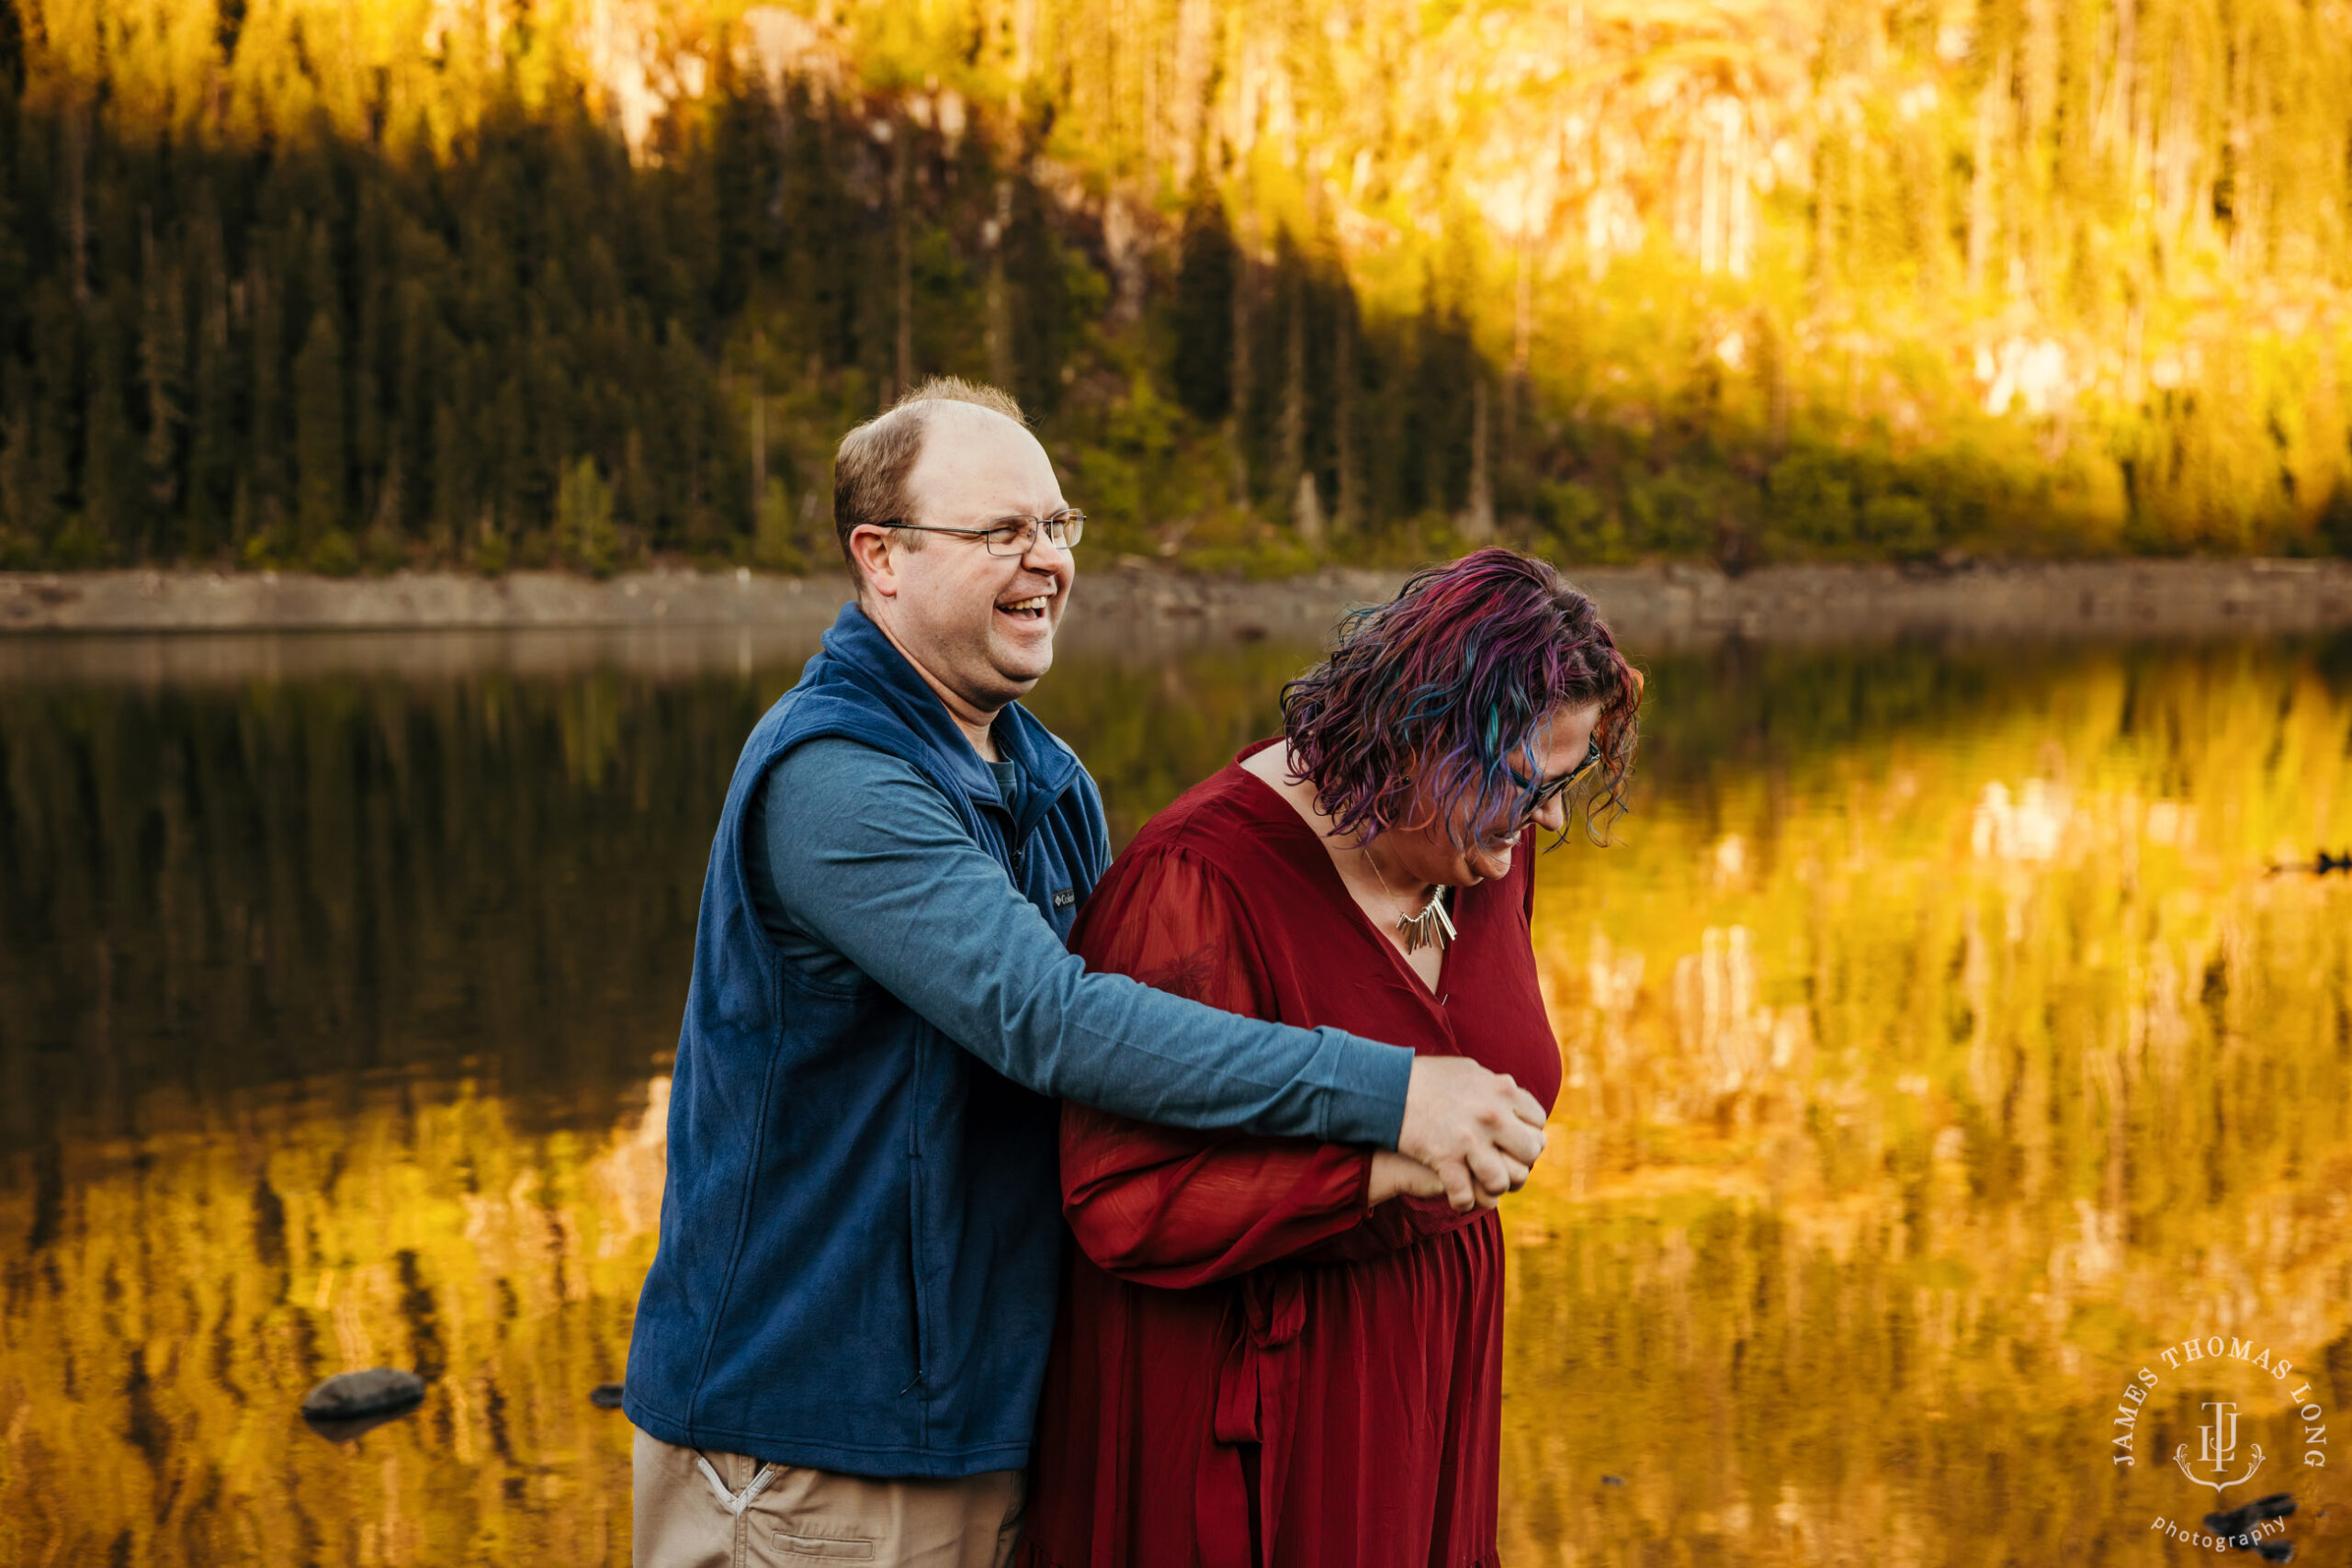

{"left": 1061, "top": 849, "right": 1385, "bottom": 1288}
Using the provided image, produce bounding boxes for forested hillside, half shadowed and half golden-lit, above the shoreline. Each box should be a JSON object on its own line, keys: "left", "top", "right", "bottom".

{"left": 0, "top": 0, "right": 2352, "bottom": 573}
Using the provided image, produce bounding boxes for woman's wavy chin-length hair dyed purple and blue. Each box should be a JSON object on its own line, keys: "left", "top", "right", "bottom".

{"left": 1282, "top": 550, "right": 1642, "bottom": 849}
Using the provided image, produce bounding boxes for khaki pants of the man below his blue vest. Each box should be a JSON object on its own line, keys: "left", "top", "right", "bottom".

{"left": 630, "top": 1432, "right": 1023, "bottom": 1568}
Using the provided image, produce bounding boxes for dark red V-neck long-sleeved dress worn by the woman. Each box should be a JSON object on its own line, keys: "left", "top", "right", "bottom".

{"left": 1018, "top": 743, "right": 1559, "bottom": 1568}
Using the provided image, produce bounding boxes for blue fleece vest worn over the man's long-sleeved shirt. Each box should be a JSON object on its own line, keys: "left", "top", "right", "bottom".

{"left": 623, "top": 604, "right": 1105, "bottom": 1476}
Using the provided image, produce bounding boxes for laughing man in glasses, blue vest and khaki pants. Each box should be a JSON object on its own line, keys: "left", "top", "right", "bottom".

{"left": 626, "top": 381, "right": 1543, "bottom": 1568}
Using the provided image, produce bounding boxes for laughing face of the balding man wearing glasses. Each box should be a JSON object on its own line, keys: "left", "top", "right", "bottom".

{"left": 868, "top": 402, "right": 1077, "bottom": 715}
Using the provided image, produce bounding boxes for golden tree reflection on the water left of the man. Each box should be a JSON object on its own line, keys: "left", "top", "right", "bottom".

{"left": 0, "top": 1079, "right": 668, "bottom": 1563}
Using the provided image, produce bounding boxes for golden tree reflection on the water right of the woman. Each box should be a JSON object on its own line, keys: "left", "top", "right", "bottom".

{"left": 1505, "top": 653, "right": 2352, "bottom": 1563}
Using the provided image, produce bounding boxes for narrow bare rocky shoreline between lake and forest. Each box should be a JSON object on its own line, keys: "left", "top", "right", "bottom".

{"left": 0, "top": 559, "right": 2352, "bottom": 649}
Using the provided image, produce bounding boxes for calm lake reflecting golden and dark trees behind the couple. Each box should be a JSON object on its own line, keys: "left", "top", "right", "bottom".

{"left": 0, "top": 632, "right": 2352, "bottom": 1568}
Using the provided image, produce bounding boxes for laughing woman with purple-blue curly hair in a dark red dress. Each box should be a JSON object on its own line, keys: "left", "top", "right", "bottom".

{"left": 1021, "top": 550, "right": 1642, "bottom": 1568}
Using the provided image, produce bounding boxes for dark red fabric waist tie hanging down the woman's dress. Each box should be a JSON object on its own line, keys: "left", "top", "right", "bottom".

{"left": 1194, "top": 1269, "right": 1307, "bottom": 1568}
